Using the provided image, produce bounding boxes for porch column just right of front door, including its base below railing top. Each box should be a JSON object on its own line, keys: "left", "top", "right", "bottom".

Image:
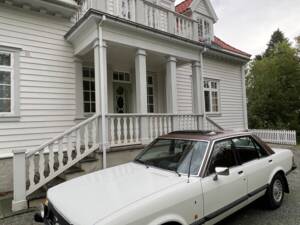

{"left": 135, "top": 49, "right": 150, "bottom": 144}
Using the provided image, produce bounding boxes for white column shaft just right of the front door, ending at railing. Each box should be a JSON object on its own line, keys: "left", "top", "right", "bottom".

{"left": 135, "top": 49, "right": 147, "bottom": 113}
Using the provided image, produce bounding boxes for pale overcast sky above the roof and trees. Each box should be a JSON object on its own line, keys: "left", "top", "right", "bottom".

{"left": 176, "top": 0, "right": 300, "bottom": 55}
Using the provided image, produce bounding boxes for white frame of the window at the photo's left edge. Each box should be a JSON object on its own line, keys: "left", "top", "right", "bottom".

{"left": 0, "top": 45, "right": 22, "bottom": 122}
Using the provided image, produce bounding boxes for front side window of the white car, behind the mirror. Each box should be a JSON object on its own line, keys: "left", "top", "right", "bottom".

{"left": 208, "top": 139, "right": 237, "bottom": 175}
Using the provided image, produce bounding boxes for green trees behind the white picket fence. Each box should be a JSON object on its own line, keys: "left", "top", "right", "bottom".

{"left": 246, "top": 31, "right": 300, "bottom": 142}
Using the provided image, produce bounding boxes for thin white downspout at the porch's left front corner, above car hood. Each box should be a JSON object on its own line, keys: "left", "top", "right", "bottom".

{"left": 98, "top": 15, "right": 107, "bottom": 169}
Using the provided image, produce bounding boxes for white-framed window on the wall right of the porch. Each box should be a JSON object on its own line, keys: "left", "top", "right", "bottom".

{"left": 204, "top": 79, "right": 220, "bottom": 113}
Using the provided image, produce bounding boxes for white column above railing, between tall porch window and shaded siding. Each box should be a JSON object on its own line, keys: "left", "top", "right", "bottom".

{"left": 166, "top": 56, "right": 177, "bottom": 113}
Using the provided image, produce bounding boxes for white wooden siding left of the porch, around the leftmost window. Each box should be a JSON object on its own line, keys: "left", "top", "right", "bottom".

{"left": 0, "top": 4, "right": 76, "bottom": 155}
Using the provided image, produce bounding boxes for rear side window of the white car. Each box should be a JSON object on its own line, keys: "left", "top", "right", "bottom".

{"left": 233, "top": 137, "right": 268, "bottom": 164}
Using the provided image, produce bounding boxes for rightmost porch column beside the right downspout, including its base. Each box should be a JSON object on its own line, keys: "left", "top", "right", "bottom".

{"left": 192, "top": 61, "right": 204, "bottom": 130}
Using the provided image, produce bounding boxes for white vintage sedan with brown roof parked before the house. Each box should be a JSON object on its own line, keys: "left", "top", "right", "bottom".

{"left": 35, "top": 131, "right": 295, "bottom": 225}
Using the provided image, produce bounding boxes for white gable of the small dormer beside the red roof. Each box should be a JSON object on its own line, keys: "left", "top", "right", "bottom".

{"left": 190, "top": 0, "right": 218, "bottom": 23}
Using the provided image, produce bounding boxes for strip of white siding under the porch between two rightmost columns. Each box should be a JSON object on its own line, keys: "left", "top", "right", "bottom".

{"left": 176, "top": 64, "right": 193, "bottom": 113}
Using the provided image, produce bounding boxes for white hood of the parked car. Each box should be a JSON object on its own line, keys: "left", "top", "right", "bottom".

{"left": 47, "top": 163, "right": 183, "bottom": 225}
